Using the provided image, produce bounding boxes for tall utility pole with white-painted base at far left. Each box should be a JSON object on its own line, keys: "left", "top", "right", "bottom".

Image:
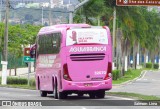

{"left": 1, "top": 0, "right": 9, "bottom": 85}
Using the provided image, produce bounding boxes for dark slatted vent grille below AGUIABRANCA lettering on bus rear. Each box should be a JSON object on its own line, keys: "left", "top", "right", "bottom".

{"left": 70, "top": 53, "right": 105, "bottom": 61}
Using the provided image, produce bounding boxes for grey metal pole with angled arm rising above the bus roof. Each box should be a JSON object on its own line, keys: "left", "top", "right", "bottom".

{"left": 69, "top": 0, "right": 89, "bottom": 24}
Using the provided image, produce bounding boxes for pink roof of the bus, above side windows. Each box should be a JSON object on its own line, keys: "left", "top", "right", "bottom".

{"left": 38, "top": 24, "right": 91, "bottom": 35}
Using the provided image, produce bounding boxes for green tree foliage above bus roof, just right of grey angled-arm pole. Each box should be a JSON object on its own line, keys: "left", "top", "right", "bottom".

{"left": 74, "top": 0, "right": 107, "bottom": 25}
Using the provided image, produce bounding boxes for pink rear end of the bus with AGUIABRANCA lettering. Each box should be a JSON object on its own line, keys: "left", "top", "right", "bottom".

{"left": 61, "top": 27, "right": 112, "bottom": 98}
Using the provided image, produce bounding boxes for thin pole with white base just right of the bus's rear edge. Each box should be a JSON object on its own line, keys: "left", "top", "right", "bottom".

{"left": 112, "top": 7, "right": 116, "bottom": 70}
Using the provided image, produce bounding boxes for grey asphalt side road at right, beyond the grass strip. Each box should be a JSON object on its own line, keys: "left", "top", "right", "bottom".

{"left": 110, "top": 71, "right": 160, "bottom": 97}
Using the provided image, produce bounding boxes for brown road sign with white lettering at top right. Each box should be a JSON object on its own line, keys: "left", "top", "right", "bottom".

{"left": 116, "top": 0, "right": 160, "bottom": 6}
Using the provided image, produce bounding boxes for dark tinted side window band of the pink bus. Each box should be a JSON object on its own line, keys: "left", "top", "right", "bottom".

{"left": 38, "top": 33, "right": 61, "bottom": 54}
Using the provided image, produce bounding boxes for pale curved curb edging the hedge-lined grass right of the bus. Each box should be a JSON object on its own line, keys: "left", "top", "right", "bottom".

{"left": 113, "top": 70, "right": 147, "bottom": 86}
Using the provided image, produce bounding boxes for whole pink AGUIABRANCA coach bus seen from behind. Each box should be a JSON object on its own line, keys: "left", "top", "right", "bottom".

{"left": 31, "top": 24, "right": 112, "bottom": 99}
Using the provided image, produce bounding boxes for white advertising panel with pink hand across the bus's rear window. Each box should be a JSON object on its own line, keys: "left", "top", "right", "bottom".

{"left": 66, "top": 28, "right": 108, "bottom": 46}
